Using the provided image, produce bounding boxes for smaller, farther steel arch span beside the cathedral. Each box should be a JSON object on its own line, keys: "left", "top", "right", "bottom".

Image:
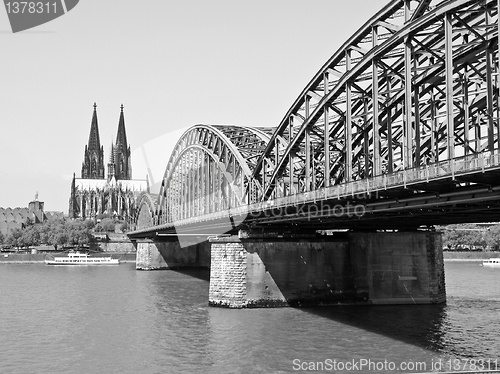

{"left": 154, "top": 124, "right": 274, "bottom": 225}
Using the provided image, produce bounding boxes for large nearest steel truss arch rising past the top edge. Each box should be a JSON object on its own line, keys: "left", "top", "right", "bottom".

{"left": 252, "top": 0, "right": 500, "bottom": 202}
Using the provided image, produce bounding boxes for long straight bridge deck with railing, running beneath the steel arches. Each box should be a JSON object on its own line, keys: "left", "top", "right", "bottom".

{"left": 129, "top": 154, "right": 500, "bottom": 236}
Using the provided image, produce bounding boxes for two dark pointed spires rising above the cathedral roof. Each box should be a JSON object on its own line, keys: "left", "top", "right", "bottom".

{"left": 82, "top": 103, "right": 132, "bottom": 181}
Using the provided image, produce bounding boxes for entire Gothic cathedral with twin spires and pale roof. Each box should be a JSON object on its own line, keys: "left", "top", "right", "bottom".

{"left": 69, "top": 103, "right": 149, "bottom": 221}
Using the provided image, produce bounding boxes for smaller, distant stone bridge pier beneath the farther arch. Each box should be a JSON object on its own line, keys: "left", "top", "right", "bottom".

{"left": 135, "top": 237, "right": 210, "bottom": 270}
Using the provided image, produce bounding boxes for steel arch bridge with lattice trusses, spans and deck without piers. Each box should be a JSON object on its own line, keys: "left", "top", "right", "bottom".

{"left": 131, "top": 0, "right": 500, "bottom": 235}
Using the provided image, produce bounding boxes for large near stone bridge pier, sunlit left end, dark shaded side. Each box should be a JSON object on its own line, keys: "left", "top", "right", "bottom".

{"left": 209, "top": 231, "right": 446, "bottom": 308}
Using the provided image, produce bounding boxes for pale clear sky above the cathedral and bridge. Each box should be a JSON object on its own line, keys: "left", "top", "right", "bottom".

{"left": 0, "top": 0, "right": 388, "bottom": 214}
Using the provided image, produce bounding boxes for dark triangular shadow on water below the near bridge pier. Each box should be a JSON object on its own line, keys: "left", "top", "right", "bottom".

{"left": 297, "top": 304, "right": 446, "bottom": 352}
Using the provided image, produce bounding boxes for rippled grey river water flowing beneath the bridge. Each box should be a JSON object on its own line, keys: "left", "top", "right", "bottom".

{"left": 0, "top": 262, "right": 500, "bottom": 374}
